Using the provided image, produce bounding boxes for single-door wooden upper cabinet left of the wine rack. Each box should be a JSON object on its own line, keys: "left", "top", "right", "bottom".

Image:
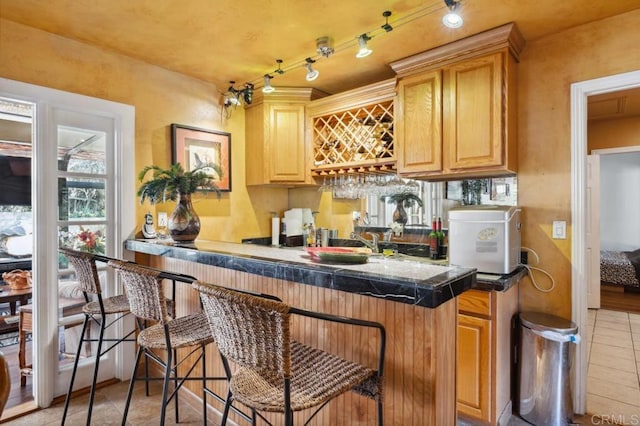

{"left": 245, "top": 87, "right": 324, "bottom": 186}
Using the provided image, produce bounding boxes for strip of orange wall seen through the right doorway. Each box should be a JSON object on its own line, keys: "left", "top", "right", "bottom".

{"left": 587, "top": 117, "right": 640, "bottom": 153}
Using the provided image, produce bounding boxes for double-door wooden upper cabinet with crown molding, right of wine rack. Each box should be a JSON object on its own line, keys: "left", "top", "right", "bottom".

{"left": 391, "top": 24, "right": 524, "bottom": 180}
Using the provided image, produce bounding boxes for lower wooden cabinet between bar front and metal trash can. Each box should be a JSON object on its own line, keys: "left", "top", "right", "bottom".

{"left": 456, "top": 284, "right": 518, "bottom": 425}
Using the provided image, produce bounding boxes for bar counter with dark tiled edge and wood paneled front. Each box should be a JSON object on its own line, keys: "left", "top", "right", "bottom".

{"left": 125, "top": 240, "right": 476, "bottom": 425}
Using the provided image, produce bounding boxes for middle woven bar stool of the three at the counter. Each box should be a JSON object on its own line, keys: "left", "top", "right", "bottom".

{"left": 109, "top": 261, "right": 215, "bottom": 425}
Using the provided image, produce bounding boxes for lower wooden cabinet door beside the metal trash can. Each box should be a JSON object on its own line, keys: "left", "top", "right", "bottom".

{"left": 456, "top": 314, "right": 491, "bottom": 423}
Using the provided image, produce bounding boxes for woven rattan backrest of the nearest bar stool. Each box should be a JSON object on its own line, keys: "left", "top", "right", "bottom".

{"left": 194, "top": 281, "right": 291, "bottom": 378}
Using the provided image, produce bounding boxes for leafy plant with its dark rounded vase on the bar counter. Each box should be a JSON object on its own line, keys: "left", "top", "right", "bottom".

{"left": 138, "top": 163, "right": 222, "bottom": 242}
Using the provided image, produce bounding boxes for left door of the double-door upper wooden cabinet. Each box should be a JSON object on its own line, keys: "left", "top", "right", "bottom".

{"left": 396, "top": 70, "right": 442, "bottom": 175}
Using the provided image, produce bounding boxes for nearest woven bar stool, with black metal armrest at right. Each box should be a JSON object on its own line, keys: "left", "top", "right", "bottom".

{"left": 193, "top": 281, "right": 386, "bottom": 426}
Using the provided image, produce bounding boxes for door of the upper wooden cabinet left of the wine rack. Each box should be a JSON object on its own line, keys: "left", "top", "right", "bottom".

{"left": 266, "top": 104, "right": 308, "bottom": 182}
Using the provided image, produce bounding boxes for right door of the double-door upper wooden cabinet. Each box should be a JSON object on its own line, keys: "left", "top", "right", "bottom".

{"left": 444, "top": 52, "right": 505, "bottom": 171}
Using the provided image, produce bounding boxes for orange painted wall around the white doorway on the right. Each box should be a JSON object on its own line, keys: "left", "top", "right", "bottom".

{"left": 518, "top": 10, "right": 640, "bottom": 318}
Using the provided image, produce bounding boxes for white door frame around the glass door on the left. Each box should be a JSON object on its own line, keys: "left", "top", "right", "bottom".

{"left": 0, "top": 78, "right": 135, "bottom": 407}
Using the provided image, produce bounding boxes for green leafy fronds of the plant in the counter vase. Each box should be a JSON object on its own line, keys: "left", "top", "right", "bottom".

{"left": 138, "top": 163, "right": 222, "bottom": 204}
